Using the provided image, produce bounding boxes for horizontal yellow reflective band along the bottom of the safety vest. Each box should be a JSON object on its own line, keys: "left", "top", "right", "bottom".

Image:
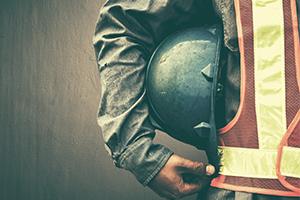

{"left": 219, "top": 147, "right": 300, "bottom": 179}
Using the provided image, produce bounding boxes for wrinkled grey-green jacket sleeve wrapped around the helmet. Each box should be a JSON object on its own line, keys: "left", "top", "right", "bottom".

{"left": 93, "top": 0, "right": 207, "bottom": 185}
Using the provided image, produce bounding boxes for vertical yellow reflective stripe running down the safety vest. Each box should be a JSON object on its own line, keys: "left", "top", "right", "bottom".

{"left": 252, "top": 0, "right": 286, "bottom": 149}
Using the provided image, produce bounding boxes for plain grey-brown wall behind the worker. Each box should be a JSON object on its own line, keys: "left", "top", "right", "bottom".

{"left": 0, "top": 0, "right": 206, "bottom": 200}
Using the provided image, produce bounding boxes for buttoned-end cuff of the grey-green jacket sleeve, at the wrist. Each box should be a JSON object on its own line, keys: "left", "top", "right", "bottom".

{"left": 117, "top": 138, "right": 173, "bottom": 186}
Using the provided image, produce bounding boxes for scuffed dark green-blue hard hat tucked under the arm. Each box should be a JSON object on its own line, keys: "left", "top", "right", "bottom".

{"left": 146, "top": 26, "right": 222, "bottom": 172}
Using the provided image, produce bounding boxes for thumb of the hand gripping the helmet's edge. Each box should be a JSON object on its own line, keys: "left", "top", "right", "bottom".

{"left": 181, "top": 160, "right": 215, "bottom": 176}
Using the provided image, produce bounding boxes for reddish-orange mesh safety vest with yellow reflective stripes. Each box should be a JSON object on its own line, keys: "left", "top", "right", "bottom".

{"left": 211, "top": 0, "right": 300, "bottom": 196}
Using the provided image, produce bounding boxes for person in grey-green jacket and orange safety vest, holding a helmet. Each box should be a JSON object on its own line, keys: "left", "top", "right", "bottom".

{"left": 93, "top": 0, "right": 300, "bottom": 200}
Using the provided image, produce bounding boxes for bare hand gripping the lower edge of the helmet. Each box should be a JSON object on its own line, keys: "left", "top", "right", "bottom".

{"left": 149, "top": 155, "right": 215, "bottom": 199}
